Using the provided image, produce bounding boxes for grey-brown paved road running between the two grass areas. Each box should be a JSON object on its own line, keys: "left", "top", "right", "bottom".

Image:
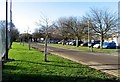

{"left": 32, "top": 44, "right": 120, "bottom": 77}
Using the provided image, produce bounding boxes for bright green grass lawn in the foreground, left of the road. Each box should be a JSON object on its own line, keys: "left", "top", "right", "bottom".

{"left": 2, "top": 43, "right": 118, "bottom": 82}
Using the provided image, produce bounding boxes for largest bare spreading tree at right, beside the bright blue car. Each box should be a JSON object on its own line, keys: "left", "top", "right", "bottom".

{"left": 88, "top": 9, "right": 117, "bottom": 48}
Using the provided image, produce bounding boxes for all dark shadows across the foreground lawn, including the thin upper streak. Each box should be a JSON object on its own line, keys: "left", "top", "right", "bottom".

{"left": 2, "top": 60, "right": 118, "bottom": 82}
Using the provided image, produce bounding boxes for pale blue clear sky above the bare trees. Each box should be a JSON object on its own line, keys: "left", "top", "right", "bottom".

{"left": 0, "top": 0, "right": 118, "bottom": 33}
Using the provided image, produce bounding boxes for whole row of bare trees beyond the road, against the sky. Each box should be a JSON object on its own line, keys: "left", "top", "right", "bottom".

{"left": 34, "top": 9, "right": 117, "bottom": 48}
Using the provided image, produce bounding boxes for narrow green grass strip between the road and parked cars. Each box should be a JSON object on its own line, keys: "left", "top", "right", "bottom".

{"left": 47, "top": 43, "right": 118, "bottom": 53}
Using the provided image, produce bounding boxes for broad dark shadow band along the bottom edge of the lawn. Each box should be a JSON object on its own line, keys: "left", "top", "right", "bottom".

{"left": 2, "top": 73, "right": 118, "bottom": 82}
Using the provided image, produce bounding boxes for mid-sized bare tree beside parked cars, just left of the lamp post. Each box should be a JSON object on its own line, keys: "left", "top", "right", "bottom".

{"left": 58, "top": 17, "right": 87, "bottom": 47}
